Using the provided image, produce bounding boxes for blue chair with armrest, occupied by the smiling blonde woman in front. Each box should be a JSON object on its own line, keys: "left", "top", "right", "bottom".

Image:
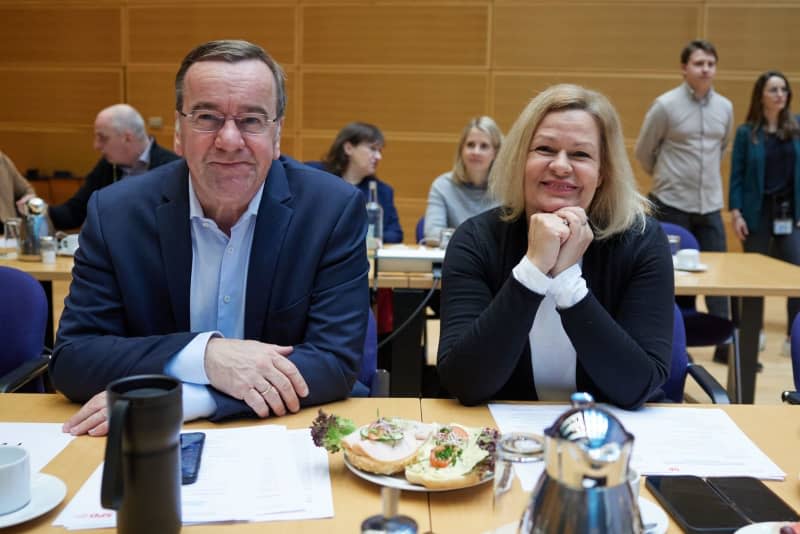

{"left": 661, "top": 304, "right": 730, "bottom": 404}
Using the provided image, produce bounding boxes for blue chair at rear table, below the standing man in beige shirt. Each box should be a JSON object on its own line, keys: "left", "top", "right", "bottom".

{"left": 661, "top": 222, "right": 738, "bottom": 350}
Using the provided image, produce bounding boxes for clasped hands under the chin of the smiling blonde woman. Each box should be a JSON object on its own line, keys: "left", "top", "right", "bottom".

{"left": 527, "top": 206, "right": 594, "bottom": 277}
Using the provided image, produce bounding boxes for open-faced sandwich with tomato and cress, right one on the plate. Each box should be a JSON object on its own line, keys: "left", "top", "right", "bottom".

{"left": 405, "top": 423, "right": 498, "bottom": 490}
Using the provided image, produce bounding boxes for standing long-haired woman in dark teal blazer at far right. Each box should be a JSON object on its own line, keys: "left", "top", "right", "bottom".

{"left": 728, "top": 70, "right": 800, "bottom": 356}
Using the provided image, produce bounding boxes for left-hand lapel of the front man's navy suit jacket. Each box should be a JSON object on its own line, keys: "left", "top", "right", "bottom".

{"left": 156, "top": 162, "right": 192, "bottom": 332}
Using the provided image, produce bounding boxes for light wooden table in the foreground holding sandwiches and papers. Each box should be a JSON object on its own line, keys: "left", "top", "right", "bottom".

{"left": 0, "top": 394, "right": 800, "bottom": 534}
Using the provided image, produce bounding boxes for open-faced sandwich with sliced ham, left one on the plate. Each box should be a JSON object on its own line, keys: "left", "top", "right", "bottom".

{"left": 311, "top": 410, "right": 434, "bottom": 475}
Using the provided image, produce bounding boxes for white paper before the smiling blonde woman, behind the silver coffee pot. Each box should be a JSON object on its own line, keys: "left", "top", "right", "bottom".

{"left": 489, "top": 404, "right": 786, "bottom": 491}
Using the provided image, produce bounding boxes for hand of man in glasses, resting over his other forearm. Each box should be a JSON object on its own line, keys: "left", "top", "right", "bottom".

{"left": 205, "top": 338, "right": 308, "bottom": 417}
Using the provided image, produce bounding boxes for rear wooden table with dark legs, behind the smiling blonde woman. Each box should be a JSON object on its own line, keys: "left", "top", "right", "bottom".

{"left": 374, "top": 252, "right": 800, "bottom": 404}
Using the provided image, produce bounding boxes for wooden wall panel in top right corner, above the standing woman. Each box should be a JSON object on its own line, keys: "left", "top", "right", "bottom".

{"left": 708, "top": 3, "right": 800, "bottom": 72}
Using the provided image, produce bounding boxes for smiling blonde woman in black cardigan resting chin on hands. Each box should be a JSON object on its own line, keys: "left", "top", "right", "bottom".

{"left": 438, "top": 85, "right": 674, "bottom": 409}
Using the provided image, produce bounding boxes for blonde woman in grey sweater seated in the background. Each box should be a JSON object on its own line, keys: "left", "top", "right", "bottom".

{"left": 425, "top": 116, "right": 503, "bottom": 244}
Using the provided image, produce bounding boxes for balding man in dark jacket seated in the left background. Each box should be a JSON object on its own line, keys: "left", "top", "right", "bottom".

{"left": 49, "top": 104, "right": 179, "bottom": 230}
